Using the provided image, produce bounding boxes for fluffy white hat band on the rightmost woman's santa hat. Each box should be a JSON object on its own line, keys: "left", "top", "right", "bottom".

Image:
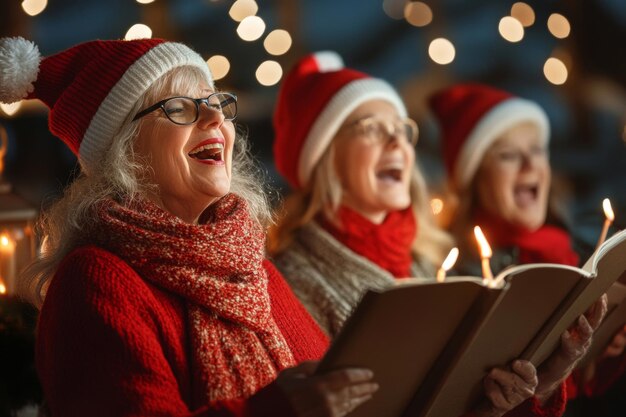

{"left": 454, "top": 97, "right": 550, "bottom": 191}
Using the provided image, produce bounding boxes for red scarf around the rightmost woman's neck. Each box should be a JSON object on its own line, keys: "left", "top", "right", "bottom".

{"left": 476, "top": 213, "right": 578, "bottom": 266}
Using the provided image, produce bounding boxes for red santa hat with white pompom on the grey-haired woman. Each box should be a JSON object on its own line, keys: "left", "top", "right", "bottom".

{"left": 0, "top": 37, "right": 213, "bottom": 173}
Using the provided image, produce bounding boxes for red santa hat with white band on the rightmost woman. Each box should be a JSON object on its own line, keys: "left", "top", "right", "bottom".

{"left": 429, "top": 84, "right": 550, "bottom": 191}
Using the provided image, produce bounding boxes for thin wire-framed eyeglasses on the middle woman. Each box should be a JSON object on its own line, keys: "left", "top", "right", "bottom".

{"left": 347, "top": 116, "right": 419, "bottom": 146}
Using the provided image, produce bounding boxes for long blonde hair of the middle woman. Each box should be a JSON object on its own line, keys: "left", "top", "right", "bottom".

{"left": 268, "top": 143, "right": 453, "bottom": 265}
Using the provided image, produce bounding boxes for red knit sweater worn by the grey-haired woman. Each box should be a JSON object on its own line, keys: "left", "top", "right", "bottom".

{"left": 36, "top": 246, "right": 328, "bottom": 417}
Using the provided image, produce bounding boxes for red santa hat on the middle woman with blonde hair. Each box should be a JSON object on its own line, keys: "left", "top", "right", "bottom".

{"left": 274, "top": 51, "right": 407, "bottom": 189}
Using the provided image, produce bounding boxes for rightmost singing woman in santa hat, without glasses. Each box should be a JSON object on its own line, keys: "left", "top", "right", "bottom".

{"left": 429, "top": 84, "right": 612, "bottom": 412}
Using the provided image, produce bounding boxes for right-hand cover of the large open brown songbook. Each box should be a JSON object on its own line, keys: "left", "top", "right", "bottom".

{"left": 415, "top": 264, "right": 580, "bottom": 417}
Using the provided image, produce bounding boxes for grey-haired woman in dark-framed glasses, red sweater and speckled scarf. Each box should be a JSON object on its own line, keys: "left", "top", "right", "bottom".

{"left": 0, "top": 38, "right": 377, "bottom": 417}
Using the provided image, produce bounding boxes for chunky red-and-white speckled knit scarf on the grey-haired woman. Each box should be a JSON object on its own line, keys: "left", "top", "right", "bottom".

{"left": 89, "top": 194, "right": 294, "bottom": 403}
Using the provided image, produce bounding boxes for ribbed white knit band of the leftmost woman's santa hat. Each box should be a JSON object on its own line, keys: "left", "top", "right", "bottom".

{"left": 79, "top": 42, "right": 213, "bottom": 172}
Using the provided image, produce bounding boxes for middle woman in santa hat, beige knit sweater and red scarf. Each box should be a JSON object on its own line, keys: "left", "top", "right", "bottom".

{"left": 269, "top": 52, "right": 555, "bottom": 417}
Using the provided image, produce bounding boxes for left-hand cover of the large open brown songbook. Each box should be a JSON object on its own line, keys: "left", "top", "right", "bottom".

{"left": 318, "top": 281, "right": 502, "bottom": 417}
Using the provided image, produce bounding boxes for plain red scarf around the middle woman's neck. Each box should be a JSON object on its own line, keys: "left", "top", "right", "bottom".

{"left": 321, "top": 206, "right": 417, "bottom": 278}
